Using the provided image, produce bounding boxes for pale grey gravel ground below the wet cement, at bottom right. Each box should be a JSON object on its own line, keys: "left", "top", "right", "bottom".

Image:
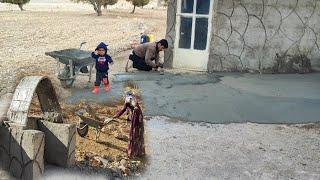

{"left": 142, "top": 117, "right": 320, "bottom": 180}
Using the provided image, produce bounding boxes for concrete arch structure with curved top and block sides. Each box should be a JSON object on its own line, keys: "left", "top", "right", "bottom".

{"left": 0, "top": 76, "right": 76, "bottom": 179}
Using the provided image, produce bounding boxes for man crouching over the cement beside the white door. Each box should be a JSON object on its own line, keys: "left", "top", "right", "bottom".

{"left": 126, "top": 39, "right": 168, "bottom": 72}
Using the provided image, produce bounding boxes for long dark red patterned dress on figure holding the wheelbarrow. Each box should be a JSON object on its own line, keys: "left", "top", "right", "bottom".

{"left": 115, "top": 103, "right": 145, "bottom": 157}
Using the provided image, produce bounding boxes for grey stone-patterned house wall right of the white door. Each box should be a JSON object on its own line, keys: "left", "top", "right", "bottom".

{"left": 208, "top": 0, "right": 320, "bottom": 72}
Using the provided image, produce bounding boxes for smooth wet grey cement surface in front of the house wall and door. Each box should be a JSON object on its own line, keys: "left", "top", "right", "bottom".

{"left": 66, "top": 72, "right": 320, "bottom": 123}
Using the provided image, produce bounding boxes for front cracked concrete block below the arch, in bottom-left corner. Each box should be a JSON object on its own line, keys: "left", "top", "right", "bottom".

{"left": 0, "top": 126, "right": 45, "bottom": 180}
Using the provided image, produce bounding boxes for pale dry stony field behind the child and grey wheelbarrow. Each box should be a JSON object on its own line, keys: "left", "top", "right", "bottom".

{"left": 0, "top": 4, "right": 166, "bottom": 95}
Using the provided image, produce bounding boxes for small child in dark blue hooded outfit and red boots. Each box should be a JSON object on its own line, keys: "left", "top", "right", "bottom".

{"left": 91, "top": 42, "right": 113, "bottom": 94}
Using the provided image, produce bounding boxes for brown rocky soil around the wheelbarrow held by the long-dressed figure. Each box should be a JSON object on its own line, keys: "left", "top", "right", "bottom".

{"left": 29, "top": 87, "right": 146, "bottom": 177}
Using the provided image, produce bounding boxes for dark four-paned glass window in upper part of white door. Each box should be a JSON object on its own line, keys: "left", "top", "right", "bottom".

{"left": 179, "top": 0, "right": 210, "bottom": 50}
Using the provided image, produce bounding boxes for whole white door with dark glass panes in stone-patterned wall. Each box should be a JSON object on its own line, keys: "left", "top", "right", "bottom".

{"left": 173, "top": 0, "right": 213, "bottom": 71}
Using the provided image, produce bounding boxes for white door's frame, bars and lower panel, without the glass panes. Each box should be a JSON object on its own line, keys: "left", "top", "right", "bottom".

{"left": 173, "top": 0, "right": 215, "bottom": 71}
